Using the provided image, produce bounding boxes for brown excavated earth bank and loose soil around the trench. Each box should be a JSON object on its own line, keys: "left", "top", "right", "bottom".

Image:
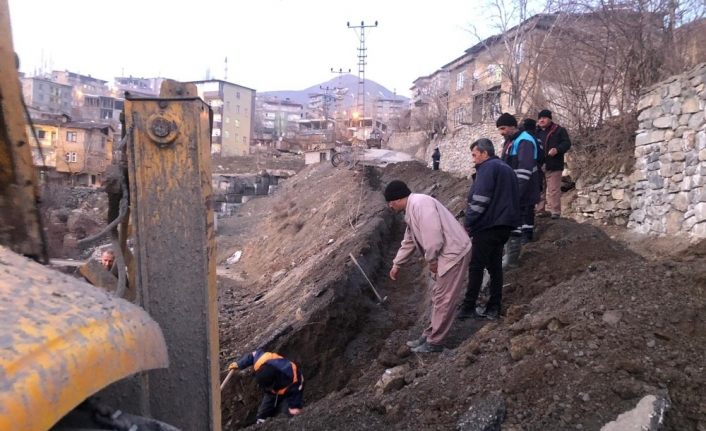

{"left": 218, "top": 162, "right": 706, "bottom": 430}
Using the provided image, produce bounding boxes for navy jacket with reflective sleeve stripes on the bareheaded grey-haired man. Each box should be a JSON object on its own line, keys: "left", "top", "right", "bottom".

{"left": 464, "top": 156, "right": 522, "bottom": 236}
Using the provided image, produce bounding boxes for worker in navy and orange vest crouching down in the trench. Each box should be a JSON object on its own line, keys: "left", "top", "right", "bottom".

{"left": 228, "top": 350, "right": 304, "bottom": 423}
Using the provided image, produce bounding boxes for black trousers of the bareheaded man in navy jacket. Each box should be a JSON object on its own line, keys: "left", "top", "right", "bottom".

{"left": 463, "top": 226, "right": 512, "bottom": 310}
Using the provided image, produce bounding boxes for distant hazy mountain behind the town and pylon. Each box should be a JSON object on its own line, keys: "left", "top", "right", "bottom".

{"left": 258, "top": 74, "right": 408, "bottom": 108}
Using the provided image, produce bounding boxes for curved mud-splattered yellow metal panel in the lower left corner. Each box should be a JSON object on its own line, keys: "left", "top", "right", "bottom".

{"left": 0, "top": 246, "right": 169, "bottom": 431}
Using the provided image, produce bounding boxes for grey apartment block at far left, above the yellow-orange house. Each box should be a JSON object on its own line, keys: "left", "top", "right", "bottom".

{"left": 21, "top": 76, "right": 72, "bottom": 114}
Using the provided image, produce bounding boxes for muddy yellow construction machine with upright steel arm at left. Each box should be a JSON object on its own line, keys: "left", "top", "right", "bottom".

{"left": 0, "top": 0, "right": 220, "bottom": 431}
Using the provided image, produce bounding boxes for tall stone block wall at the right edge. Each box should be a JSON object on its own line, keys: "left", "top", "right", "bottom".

{"left": 628, "top": 63, "right": 706, "bottom": 238}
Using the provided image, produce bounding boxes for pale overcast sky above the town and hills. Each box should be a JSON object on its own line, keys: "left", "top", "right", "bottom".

{"left": 9, "top": 0, "right": 490, "bottom": 96}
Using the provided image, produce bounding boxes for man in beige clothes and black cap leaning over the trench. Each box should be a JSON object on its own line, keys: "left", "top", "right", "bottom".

{"left": 384, "top": 180, "right": 471, "bottom": 353}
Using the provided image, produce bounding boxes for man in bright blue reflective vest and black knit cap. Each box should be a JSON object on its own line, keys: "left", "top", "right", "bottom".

{"left": 495, "top": 112, "right": 542, "bottom": 266}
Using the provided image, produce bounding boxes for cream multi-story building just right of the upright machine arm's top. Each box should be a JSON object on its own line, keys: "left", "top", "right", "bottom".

{"left": 193, "top": 79, "right": 255, "bottom": 157}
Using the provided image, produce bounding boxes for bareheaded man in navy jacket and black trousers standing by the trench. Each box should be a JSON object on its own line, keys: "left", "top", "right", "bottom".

{"left": 458, "top": 139, "right": 520, "bottom": 320}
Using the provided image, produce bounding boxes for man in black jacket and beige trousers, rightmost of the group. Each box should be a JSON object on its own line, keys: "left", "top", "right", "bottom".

{"left": 537, "top": 109, "right": 571, "bottom": 219}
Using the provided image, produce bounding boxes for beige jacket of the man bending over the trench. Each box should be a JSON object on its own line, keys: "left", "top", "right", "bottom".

{"left": 392, "top": 193, "right": 471, "bottom": 276}
